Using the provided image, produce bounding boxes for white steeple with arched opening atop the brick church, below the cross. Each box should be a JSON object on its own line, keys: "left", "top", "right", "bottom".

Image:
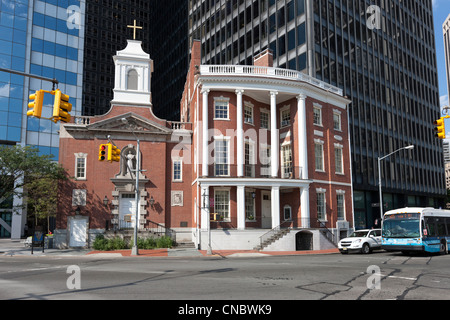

{"left": 111, "top": 40, "right": 153, "bottom": 106}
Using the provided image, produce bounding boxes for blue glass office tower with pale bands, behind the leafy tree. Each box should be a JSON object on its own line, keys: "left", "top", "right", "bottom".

{"left": 0, "top": 0, "right": 85, "bottom": 238}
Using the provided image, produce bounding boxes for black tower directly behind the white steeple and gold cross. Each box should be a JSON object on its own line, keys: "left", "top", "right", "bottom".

{"left": 83, "top": 0, "right": 153, "bottom": 116}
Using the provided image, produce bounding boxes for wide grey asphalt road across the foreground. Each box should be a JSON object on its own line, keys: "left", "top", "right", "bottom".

{"left": 0, "top": 252, "right": 450, "bottom": 302}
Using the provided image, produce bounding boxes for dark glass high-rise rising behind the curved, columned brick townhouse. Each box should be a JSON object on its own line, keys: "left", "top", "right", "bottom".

{"left": 189, "top": 0, "right": 445, "bottom": 228}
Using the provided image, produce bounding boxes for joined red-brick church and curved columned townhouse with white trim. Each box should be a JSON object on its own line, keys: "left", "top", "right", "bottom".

{"left": 55, "top": 40, "right": 353, "bottom": 250}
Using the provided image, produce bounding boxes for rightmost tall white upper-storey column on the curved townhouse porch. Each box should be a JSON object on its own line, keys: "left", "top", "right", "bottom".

{"left": 297, "top": 94, "right": 308, "bottom": 179}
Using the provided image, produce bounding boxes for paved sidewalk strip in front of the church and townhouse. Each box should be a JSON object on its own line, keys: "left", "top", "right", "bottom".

{"left": 0, "top": 239, "right": 339, "bottom": 258}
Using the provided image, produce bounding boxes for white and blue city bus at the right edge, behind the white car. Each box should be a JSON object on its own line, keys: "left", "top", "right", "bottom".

{"left": 381, "top": 208, "right": 450, "bottom": 254}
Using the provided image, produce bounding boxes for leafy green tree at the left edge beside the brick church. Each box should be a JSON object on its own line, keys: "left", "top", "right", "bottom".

{"left": 0, "top": 145, "right": 67, "bottom": 209}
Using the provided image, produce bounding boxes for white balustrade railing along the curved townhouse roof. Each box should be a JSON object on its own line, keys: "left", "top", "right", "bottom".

{"left": 200, "top": 65, "right": 343, "bottom": 96}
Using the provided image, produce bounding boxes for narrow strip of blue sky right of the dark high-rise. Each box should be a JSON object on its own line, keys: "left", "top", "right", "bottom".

{"left": 433, "top": 0, "right": 450, "bottom": 107}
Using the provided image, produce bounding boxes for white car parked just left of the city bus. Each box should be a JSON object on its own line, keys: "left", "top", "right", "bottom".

{"left": 338, "top": 229, "right": 381, "bottom": 254}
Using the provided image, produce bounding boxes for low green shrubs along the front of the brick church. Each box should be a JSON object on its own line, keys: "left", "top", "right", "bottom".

{"left": 93, "top": 234, "right": 173, "bottom": 251}
